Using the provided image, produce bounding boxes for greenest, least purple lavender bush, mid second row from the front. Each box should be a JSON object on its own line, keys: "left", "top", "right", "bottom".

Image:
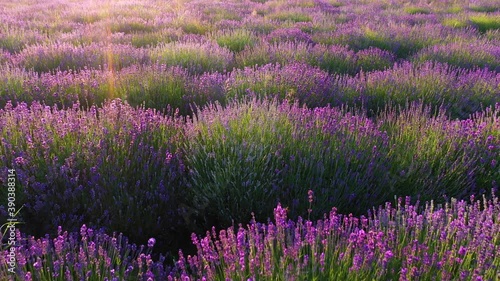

{"left": 185, "top": 99, "right": 292, "bottom": 227}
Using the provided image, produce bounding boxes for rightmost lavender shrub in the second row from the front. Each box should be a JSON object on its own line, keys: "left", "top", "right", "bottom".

{"left": 379, "top": 103, "right": 500, "bottom": 201}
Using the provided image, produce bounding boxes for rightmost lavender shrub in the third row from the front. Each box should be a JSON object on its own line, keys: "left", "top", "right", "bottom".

{"left": 350, "top": 62, "right": 500, "bottom": 118}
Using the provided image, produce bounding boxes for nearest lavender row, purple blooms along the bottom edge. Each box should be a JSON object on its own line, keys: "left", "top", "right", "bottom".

{"left": 0, "top": 190, "right": 500, "bottom": 281}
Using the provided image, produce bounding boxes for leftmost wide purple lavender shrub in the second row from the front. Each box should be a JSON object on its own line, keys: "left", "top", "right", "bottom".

{"left": 0, "top": 101, "right": 189, "bottom": 254}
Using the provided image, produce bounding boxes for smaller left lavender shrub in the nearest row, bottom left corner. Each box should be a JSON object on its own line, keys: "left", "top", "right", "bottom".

{"left": 0, "top": 224, "right": 166, "bottom": 281}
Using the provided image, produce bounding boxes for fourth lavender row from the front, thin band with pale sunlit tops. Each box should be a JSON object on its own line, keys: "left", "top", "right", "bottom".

{"left": 0, "top": 35, "right": 500, "bottom": 75}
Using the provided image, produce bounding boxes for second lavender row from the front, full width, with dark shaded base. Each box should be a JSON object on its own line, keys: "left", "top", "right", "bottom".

{"left": 0, "top": 97, "right": 500, "bottom": 256}
